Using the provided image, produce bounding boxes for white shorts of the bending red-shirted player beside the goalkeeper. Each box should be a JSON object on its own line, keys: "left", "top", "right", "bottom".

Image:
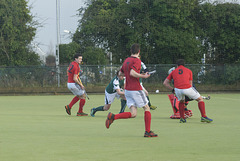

{"left": 174, "top": 87, "right": 201, "bottom": 101}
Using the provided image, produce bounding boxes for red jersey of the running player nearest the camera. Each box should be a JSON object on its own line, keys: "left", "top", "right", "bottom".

{"left": 120, "top": 56, "right": 142, "bottom": 91}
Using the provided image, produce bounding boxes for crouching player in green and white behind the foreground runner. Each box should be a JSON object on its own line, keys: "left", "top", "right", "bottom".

{"left": 90, "top": 71, "right": 126, "bottom": 117}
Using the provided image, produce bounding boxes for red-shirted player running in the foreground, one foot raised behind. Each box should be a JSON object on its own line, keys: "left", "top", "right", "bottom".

{"left": 106, "top": 44, "right": 158, "bottom": 137}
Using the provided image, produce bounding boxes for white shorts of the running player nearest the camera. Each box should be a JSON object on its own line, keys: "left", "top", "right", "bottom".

{"left": 125, "top": 90, "right": 148, "bottom": 108}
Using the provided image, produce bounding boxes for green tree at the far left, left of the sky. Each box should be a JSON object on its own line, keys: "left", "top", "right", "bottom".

{"left": 0, "top": 0, "right": 40, "bottom": 66}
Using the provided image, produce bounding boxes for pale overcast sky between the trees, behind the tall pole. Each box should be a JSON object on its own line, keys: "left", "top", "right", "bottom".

{"left": 28, "top": 0, "right": 85, "bottom": 53}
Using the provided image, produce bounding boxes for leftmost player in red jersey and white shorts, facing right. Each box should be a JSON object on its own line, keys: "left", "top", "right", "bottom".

{"left": 65, "top": 53, "right": 88, "bottom": 116}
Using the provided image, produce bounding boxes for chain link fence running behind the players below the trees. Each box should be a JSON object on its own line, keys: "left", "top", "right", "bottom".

{"left": 0, "top": 64, "right": 240, "bottom": 91}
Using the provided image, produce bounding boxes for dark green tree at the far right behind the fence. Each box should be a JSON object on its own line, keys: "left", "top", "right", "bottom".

{"left": 188, "top": 3, "right": 240, "bottom": 64}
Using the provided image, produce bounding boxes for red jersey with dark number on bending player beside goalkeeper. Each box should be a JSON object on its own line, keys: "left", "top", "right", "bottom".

{"left": 167, "top": 65, "right": 193, "bottom": 89}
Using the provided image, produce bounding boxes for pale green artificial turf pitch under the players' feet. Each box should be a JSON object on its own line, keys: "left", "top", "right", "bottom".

{"left": 0, "top": 94, "right": 240, "bottom": 161}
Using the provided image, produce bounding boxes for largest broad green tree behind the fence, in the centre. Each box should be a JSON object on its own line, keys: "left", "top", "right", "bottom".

{"left": 75, "top": 0, "right": 201, "bottom": 63}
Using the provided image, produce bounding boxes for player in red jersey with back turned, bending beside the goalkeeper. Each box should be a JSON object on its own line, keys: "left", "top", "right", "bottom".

{"left": 163, "top": 59, "right": 213, "bottom": 123}
